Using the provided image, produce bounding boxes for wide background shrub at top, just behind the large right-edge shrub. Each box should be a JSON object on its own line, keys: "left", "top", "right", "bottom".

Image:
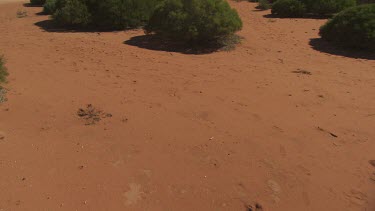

{"left": 301, "top": 0, "right": 357, "bottom": 15}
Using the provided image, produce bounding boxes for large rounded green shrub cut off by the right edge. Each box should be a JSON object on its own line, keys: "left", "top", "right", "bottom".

{"left": 320, "top": 4, "right": 375, "bottom": 51}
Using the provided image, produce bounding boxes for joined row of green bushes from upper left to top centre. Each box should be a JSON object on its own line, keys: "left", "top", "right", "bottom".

{"left": 33, "top": 0, "right": 242, "bottom": 46}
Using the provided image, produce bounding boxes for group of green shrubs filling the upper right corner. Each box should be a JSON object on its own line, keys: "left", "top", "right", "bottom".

{"left": 250, "top": 0, "right": 375, "bottom": 51}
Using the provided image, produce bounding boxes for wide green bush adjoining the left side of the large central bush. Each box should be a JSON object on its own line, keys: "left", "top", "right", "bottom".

{"left": 53, "top": 0, "right": 160, "bottom": 29}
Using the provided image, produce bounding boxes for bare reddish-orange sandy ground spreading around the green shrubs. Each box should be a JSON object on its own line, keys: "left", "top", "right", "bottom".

{"left": 0, "top": 2, "right": 375, "bottom": 211}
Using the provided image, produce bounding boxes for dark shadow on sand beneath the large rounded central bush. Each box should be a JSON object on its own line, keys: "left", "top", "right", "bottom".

{"left": 124, "top": 35, "right": 223, "bottom": 54}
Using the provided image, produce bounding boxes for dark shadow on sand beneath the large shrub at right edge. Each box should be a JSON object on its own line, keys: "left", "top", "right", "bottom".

{"left": 309, "top": 38, "right": 375, "bottom": 60}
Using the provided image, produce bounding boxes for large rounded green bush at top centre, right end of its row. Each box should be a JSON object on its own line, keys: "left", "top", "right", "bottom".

{"left": 145, "top": 0, "right": 242, "bottom": 44}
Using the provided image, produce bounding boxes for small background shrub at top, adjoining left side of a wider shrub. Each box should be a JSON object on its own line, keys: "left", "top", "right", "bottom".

{"left": 271, "top": 0, "right": 306, "bottom": 18}
